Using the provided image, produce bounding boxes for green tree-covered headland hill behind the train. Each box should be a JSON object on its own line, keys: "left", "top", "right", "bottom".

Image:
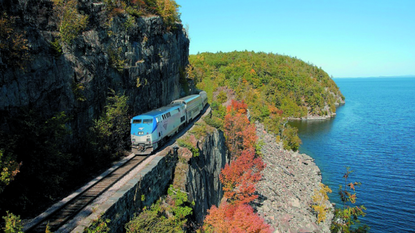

{"left": 186, "top": 51, "right": 344, "bottom": 150}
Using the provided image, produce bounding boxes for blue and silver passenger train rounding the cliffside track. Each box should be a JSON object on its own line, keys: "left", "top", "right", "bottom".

{"left": 131, "top": 91, "right": 207, "bottom": 155}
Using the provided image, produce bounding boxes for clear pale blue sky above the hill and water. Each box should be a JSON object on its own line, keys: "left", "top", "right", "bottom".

{"left": 176, "top": 0, "right": 415, "bottom": 77}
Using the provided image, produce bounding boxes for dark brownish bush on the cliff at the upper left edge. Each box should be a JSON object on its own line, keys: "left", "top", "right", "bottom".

{"left": 0, "top": 12, "right": 30, "bottom": 70}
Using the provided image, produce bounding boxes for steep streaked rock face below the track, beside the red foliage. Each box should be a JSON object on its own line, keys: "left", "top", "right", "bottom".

{"left": 186, "top": 130, "right": 229, "bottom": 223}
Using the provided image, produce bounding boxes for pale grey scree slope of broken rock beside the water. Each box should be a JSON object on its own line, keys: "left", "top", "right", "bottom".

{"left": 256, "top": 123, "right": 333, "bottom": 232}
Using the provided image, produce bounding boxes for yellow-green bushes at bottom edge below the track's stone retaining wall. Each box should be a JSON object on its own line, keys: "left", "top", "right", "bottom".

{"left": 125, "top": 185, "right": 194, "bottom": 232}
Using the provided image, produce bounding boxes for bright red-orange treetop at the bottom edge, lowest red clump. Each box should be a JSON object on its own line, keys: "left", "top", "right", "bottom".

{"left": 204, "top": 202, "right": 273, "bottom": 233}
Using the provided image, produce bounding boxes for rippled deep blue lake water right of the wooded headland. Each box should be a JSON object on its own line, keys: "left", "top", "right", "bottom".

{"left": 293, "top": 78, "right": 415, "bottom": 232}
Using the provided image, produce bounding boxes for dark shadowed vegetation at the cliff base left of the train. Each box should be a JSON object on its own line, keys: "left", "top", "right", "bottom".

{"left": 0, "top": 91, "right": 129, "bottom": 222}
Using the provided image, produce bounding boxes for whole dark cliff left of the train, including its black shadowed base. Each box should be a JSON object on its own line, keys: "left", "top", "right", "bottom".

{"left": 0, "top": 0, "right": 189, "bottom": 217}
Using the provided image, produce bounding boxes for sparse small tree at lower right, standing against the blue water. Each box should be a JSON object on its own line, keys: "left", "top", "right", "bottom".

{"left": 331, "top": 167, "right": 370, "bottom": 233}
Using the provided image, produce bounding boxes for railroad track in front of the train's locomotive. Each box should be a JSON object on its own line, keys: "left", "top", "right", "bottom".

{"left": 24, "top": 155, "right": 147, "bottom": 232}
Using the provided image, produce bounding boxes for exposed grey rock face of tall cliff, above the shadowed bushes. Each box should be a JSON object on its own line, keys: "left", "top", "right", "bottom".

{"left": 0, "top": 0, "right": 189, "bottom": 142}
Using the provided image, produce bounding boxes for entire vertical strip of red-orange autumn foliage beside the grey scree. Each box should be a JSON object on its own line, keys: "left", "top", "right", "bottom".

{"left": 203, "top": 100, "right": 272, "bottom": 233}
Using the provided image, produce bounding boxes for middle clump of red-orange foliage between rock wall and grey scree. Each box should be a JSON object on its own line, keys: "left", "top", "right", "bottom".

{"left": 219, "top": 149, "right": 265, "bottom": 204}
